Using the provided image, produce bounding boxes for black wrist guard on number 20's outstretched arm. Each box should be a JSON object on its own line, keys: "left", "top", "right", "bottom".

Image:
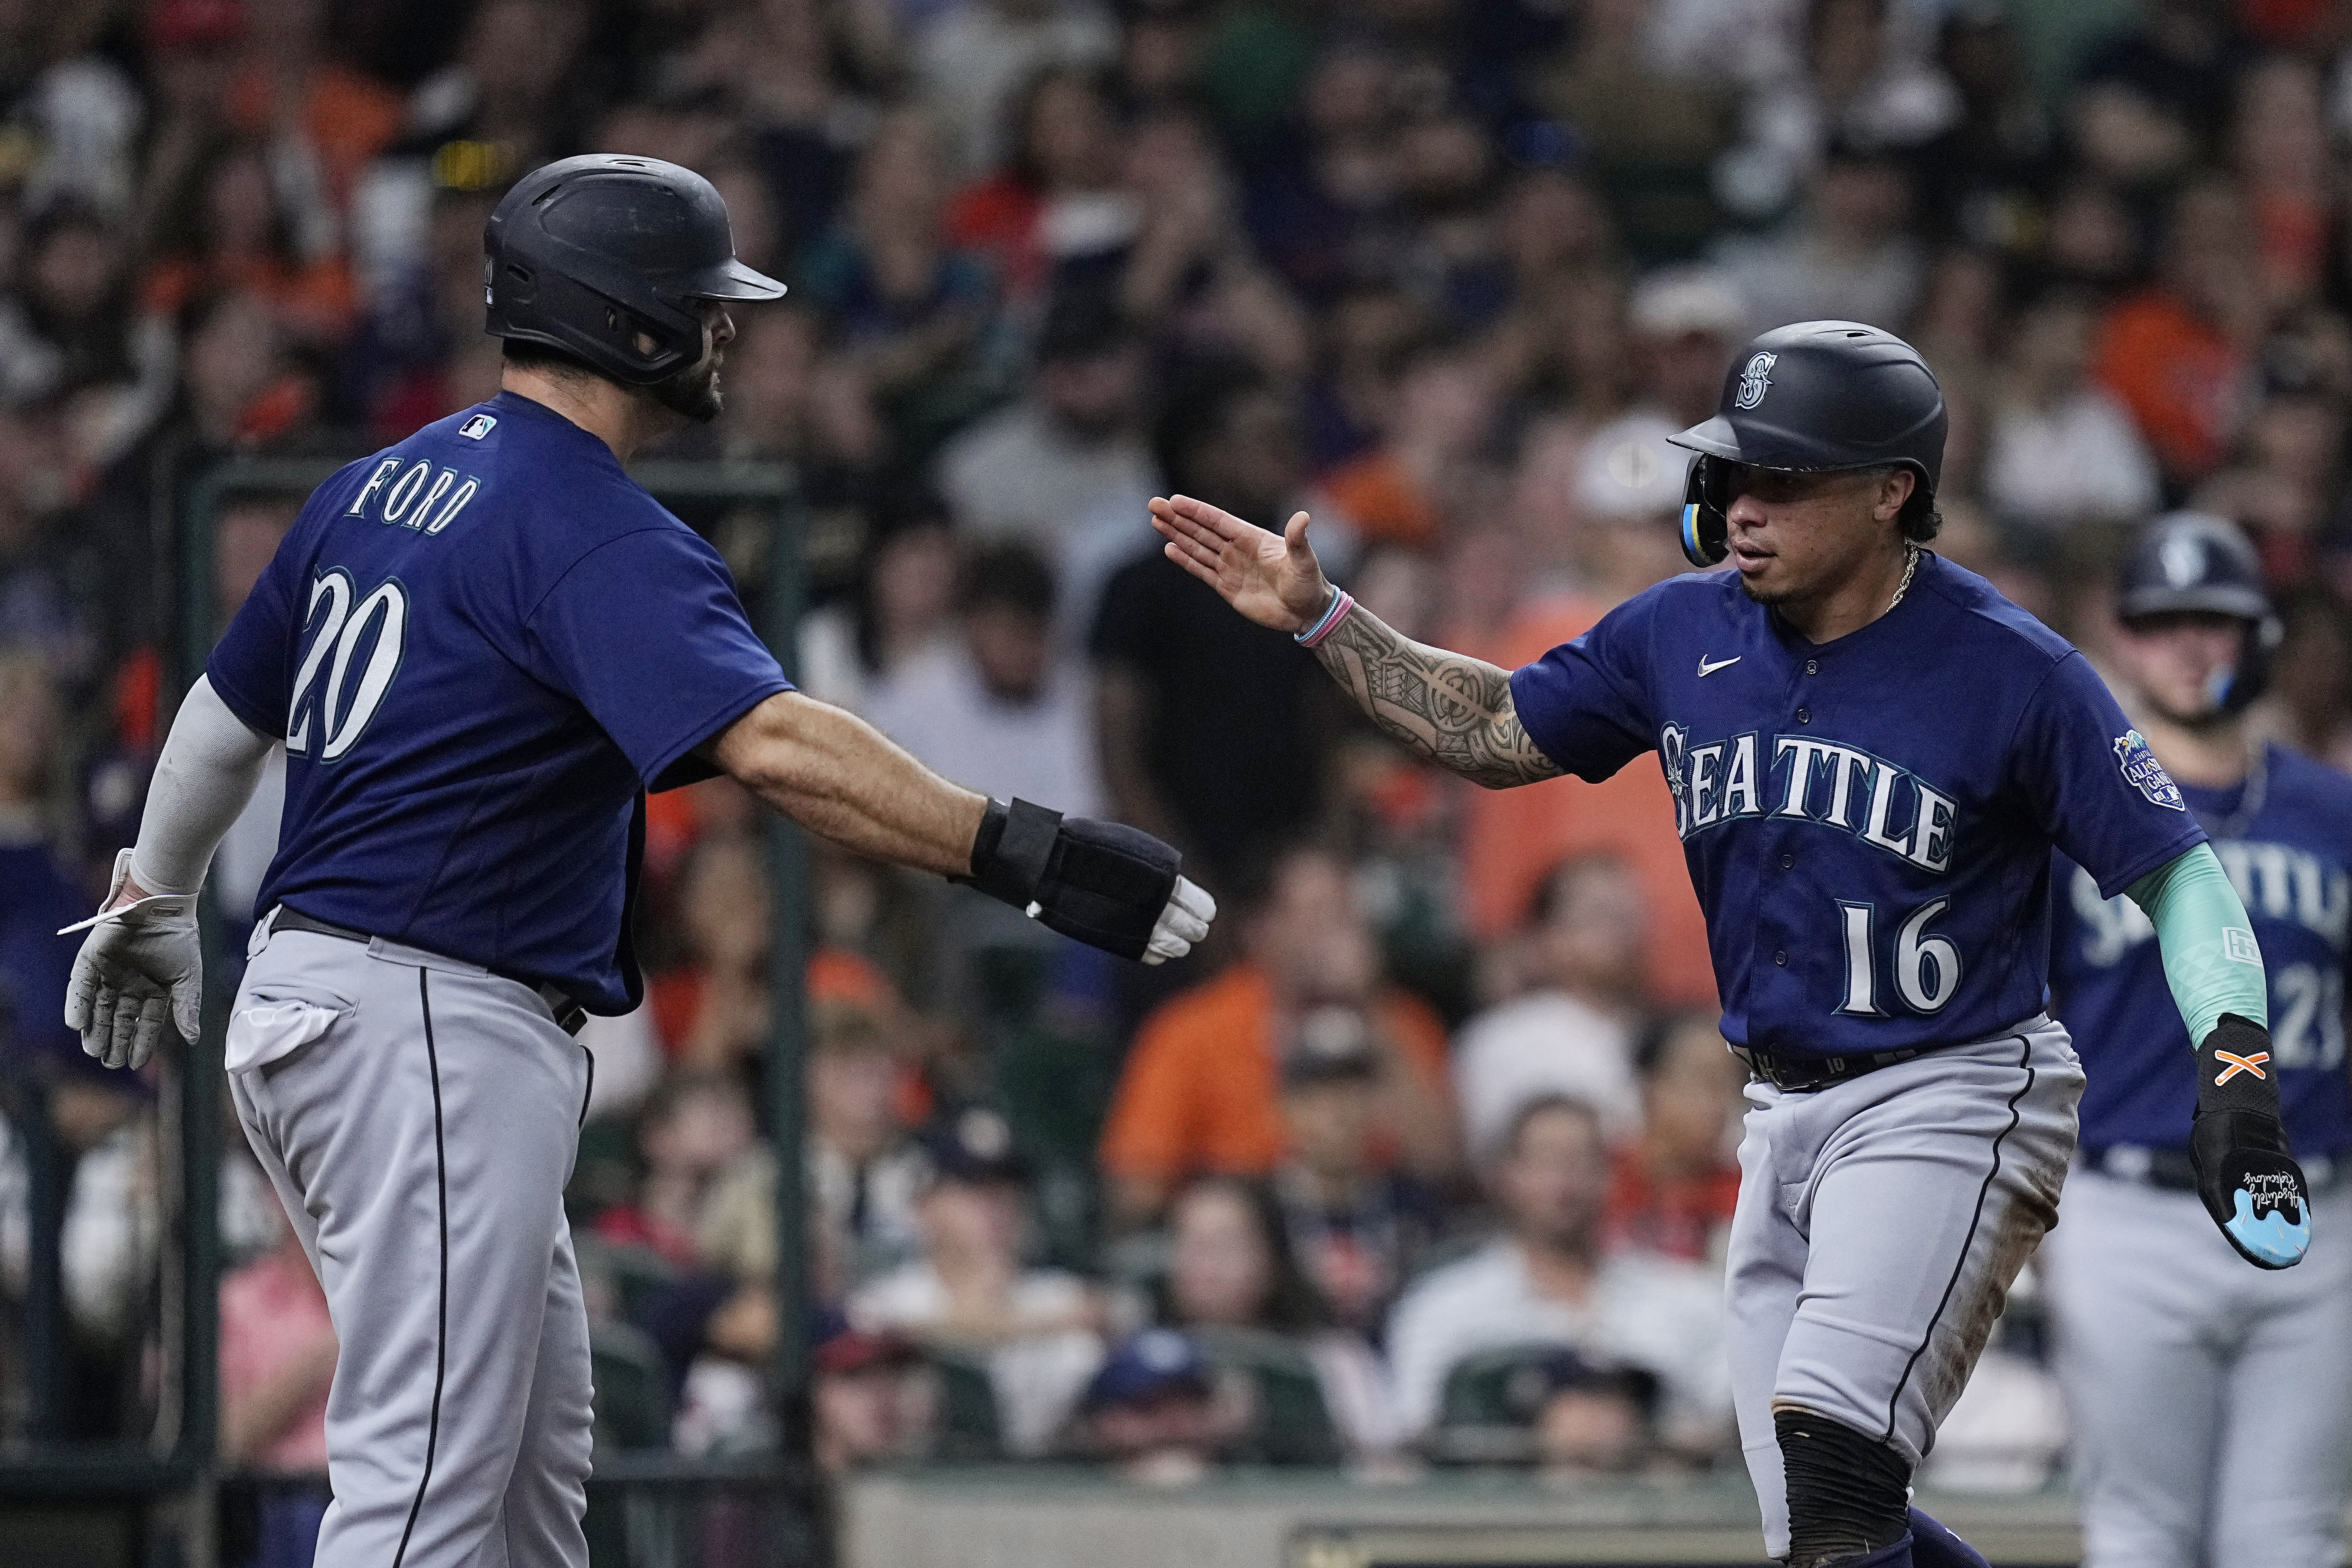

{"left": 964, "top": 799, "right": 1183, "bottom": 959}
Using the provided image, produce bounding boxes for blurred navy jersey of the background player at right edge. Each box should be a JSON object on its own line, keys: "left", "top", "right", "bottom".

{"left": 2051, "top": 745, "right": 2352, "bottom": 1156}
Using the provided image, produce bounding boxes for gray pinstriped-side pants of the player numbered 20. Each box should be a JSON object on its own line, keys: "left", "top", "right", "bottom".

{"left": 228, "top": 931, "right": 590, "bottom": 1568}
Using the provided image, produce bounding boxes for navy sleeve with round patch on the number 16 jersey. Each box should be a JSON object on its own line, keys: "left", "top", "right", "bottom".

{"left": 2013, "top": 651, "right": 2206, "bottom": 898}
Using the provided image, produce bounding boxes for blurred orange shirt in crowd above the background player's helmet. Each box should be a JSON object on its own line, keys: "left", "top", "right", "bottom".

{"left": 2093, "top": 280, "right": 2251, "bottom": 479}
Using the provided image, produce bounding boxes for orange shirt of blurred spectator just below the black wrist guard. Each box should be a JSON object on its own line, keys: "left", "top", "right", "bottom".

{"left": 1103, "top": 964, "right": 1447, "bottom": 1180}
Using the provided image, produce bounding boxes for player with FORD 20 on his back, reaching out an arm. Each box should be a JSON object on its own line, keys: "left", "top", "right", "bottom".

{"left": 66, "top": 155, "right": 1214, "bottom": 1568}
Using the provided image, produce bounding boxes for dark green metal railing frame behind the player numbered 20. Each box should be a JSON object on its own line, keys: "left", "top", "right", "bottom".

{"left": 0, "top": 446, "right": 814, "bottom": 1568}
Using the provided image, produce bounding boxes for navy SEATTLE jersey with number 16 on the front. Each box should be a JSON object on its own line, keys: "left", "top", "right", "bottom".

{"left": 1510, "top": 552, "right": 2204, "bottom": 1055}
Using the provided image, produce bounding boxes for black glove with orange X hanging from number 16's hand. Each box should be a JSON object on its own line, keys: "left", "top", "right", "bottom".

{"left": 2190, "top": 1013, "right": 2312, "bottom": 1269}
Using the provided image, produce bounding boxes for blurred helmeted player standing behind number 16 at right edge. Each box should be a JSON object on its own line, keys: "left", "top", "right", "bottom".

{"left": 2044, "top": 513, "right": 2352, "bottom": 1568}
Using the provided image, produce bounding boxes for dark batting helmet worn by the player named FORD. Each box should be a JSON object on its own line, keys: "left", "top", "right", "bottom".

{"left": 482, "top": 153, "right": 783, "bottom": 385}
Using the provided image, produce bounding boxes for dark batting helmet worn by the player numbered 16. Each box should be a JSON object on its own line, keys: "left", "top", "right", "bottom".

{"left": 1670, "top": 322, "right": 1945, "bottom": 567}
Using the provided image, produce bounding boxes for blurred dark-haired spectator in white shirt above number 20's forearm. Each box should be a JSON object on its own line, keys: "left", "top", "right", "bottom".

{"left": 866, "top": 538, "right": 1103, "bottom": 816}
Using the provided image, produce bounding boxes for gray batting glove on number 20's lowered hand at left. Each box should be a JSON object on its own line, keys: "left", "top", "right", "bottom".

{"left": 59, "top": 849, "right": 204, "bottom": 1072}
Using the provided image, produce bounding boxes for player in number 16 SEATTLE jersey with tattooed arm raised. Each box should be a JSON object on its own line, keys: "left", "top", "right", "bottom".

{"left": 1153, "top": 322, "right": 2310, "bottom": 1568}
